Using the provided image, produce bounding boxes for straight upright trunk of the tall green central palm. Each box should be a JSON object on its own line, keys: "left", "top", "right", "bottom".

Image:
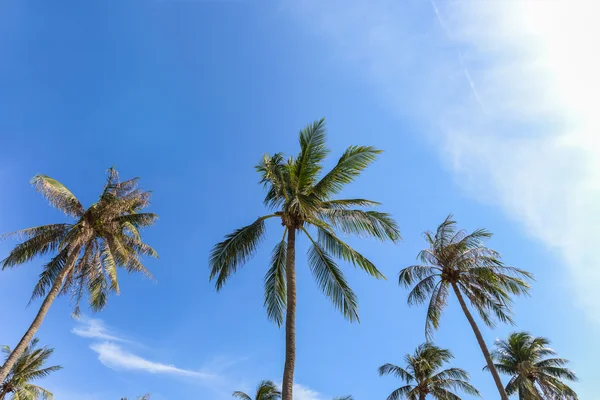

{"left": 281, "top": 228, "right": 296, "bottom": 400}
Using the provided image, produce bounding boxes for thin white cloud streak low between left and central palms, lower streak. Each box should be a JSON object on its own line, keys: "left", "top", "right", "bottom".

{"left": 90, "top": 342, "right": 216, "bottom": 380}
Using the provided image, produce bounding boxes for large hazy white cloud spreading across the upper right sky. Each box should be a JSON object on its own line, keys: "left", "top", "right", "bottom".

{"left": 291, "top": 0, "right": 600, "bottom": 324}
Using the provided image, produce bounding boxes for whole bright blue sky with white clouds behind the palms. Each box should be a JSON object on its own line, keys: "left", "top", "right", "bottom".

{"left": 0, "top": 0, "right": 600, "bottom": 400}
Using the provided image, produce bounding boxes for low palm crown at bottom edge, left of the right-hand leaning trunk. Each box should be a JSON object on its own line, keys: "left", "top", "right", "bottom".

{"left": 379, "top": 343, "right": 481, "bottom": 400}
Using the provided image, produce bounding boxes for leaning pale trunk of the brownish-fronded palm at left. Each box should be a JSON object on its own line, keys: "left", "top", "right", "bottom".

{"left": 0, "top": 247, "right": 79, "bottom": 382}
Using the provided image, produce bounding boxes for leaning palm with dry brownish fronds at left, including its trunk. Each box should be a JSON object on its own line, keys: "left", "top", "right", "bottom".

{"left": 0, "top": 168, "right": 158, "bottom": 381}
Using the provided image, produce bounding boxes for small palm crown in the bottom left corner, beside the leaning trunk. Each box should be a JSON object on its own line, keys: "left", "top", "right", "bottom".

{"left": 0, "top": 338, "right": 62, "bottom": 400}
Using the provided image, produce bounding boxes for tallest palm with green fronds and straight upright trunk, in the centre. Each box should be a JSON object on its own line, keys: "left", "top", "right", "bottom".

{"left": 210, "top": 119, "right": 400, "bottom": 400}
